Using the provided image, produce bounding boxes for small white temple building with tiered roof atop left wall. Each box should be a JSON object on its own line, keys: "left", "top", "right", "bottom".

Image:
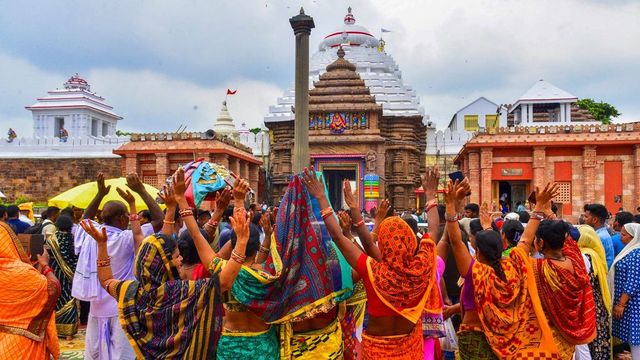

{"left": 0, "top": 74, "right": 129, "bottom": 158}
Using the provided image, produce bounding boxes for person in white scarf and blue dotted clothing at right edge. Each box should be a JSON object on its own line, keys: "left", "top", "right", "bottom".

{"left": 608, "top": 223, "right": 640, "bottom": 360}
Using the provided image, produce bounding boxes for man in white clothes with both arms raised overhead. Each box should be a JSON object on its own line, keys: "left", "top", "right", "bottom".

{"left": 71, "top": 173, "right": 163, "bottom": 360}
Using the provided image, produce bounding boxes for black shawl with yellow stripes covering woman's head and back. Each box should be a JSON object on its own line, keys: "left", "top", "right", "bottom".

{"left": 117, "top": 235, "right": 223, "bottom": 359}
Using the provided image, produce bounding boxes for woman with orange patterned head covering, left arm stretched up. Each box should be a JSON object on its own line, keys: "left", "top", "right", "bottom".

{"left": 304, "top": 169, "right": 442, "bottom": 359}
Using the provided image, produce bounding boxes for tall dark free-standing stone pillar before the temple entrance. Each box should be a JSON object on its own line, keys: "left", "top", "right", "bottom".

{"left": 289, "top": 8, "right": 315, "bottom": 174}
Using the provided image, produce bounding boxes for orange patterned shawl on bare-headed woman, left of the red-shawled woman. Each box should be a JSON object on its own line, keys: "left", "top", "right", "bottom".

{"left": 472, "top": 247, "right": 559, "bottom": 359}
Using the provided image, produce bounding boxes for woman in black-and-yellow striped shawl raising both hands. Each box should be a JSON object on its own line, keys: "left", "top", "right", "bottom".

{"left": 82, "top": 183, "right": 249, "bottom": 359}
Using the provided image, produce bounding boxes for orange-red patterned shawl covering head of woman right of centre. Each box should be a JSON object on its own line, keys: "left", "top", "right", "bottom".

{"left": 367, "top": 216, "right": 442, "bottom": 323}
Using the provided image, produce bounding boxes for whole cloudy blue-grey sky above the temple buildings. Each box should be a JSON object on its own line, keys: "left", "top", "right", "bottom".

{"left": 0, "top": 0, "right": 640, "bottom": 136}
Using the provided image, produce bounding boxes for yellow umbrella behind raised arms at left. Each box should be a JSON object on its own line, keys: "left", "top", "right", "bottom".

{"left": 49, "top": 177, "right": 158, "bottom": 211}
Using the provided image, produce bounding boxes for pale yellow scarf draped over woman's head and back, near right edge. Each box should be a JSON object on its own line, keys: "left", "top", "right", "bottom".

{"left": 578, "top": 225, "right": 612, "bottom": 313}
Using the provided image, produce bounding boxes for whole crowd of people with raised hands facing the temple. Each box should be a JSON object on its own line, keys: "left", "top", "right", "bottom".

{"left": 0, "top": 168, "right": 640, "bottom": 360}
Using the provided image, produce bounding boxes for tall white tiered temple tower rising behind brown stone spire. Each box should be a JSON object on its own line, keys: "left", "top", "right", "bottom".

{"left": 264, "top": 8, "right": 427, "bottom": 122}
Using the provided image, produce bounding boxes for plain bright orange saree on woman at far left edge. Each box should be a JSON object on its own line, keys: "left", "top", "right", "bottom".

{"left": 0, "top": 221, "right": 60, "bottom": 360}
